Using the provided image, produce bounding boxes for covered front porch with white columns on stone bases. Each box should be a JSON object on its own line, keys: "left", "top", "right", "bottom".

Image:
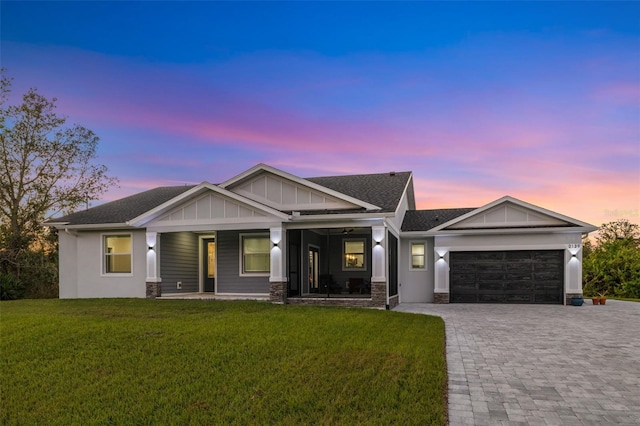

{"left": 147, "top": 221, "right": 397, "bottom": 307}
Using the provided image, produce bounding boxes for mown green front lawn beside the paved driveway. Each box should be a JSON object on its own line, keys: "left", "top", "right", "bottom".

{"left": 0, "top": 299, "right": 447, "bottom": 425}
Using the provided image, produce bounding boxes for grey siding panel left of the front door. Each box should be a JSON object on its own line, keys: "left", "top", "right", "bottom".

{"left": 160, "top": 232, "right": 199, "bottom": 293}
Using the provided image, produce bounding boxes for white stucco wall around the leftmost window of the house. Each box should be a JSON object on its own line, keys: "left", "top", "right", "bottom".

{"left": 59, "top": 230, "right": 147, "bottom": 299}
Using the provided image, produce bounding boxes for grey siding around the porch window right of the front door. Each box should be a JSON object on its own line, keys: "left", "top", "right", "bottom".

{"left": 216, "top": 229, "right": 269, "bottom": 294}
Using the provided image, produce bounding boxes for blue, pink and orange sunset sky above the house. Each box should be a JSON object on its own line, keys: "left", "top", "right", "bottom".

{"left": 0, "top": 1, "right": 640, "bottom": 225}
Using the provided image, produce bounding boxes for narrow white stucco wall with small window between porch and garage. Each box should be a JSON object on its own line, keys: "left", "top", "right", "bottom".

{"left": 398, "top": 237, "right": 433, "bottom": 303}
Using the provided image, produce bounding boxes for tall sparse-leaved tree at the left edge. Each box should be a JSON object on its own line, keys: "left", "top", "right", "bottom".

{"left": 0, "top": 70, "right": 117, "bottom": 280}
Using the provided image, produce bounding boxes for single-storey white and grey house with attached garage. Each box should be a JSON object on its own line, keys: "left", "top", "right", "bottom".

{"left": 46, "top": 164, "right": 596, "bottom": 308}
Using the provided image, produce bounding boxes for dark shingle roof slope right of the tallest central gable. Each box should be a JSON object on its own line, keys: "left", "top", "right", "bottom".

{"left": 306, "top": 172, "right": 415, "bottom": 212}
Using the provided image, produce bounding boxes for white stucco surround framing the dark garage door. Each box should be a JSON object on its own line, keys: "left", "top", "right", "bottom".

{"left": 432, "top": 232, "right": 582, "bottom": 294}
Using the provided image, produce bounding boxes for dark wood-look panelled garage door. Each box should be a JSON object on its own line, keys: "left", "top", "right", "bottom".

{"left": 449, "top": 250, "right": 564, "bottom": 304}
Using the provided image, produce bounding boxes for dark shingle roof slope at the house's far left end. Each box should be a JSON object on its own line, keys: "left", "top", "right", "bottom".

{"left": 45, "top": 185, "right": 195, "bottom": 225}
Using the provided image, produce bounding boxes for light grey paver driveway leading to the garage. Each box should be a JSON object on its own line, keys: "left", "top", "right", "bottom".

{"left": 395, "top": 300, "right": 640, "bottom": 426}
